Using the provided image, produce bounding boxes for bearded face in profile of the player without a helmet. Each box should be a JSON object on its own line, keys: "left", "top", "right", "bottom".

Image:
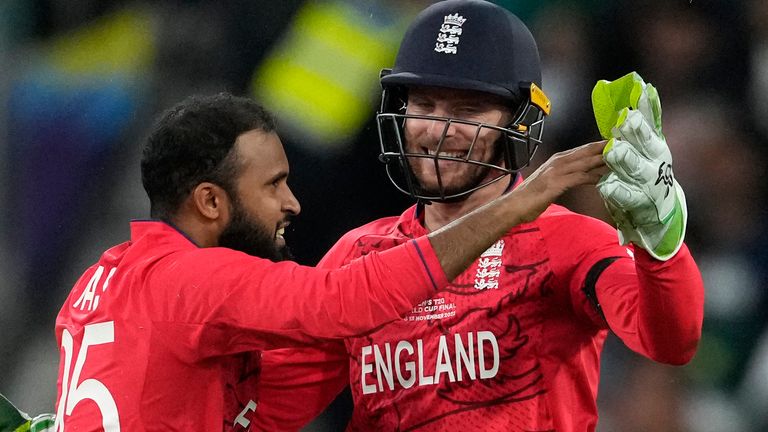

{"left": 219, "top": 130, "right": 301, "bottom": 261}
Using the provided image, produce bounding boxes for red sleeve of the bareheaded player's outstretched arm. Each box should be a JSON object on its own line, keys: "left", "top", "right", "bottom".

{"left": 150, "top": 237, "right": 447, "bottom": 360}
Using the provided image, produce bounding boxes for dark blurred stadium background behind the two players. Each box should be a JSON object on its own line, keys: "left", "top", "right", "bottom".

{"left": 0, "top": 0, "right": 768, "bottom": 432}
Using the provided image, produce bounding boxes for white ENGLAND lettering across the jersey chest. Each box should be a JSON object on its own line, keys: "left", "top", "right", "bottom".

{"left": 360, "top": 331, "right": 499, "bottom": 394}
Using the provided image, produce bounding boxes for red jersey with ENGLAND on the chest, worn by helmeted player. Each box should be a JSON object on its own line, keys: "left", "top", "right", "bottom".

{"left": 256, "top": 205, "right": 704, "bottom": 432}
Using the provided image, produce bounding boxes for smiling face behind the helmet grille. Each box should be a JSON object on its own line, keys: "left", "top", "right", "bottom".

{"left": 405, "top": 87, "right": 511, "bottom": 195}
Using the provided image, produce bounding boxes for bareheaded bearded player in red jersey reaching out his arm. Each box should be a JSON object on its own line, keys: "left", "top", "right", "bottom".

{"left": 55, "top": 90, "right": 607, "bottom": 432}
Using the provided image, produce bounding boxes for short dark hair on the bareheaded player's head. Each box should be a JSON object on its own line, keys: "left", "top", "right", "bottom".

{"left": 141, "top": 93, "right": 275, "bottom": 221}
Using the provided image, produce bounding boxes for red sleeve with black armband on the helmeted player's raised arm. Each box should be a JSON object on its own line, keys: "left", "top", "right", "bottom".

{"left": 543, "top": 212, "right": 704, "bottom": 364}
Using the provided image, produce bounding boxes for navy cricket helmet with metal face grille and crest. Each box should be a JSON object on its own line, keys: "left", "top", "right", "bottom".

{"left": 377, "top": 0, "right": 550, "bottom": 201}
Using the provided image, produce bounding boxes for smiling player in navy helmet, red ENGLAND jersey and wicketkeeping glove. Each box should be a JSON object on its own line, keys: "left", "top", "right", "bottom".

{"left": 256, "top": 0, "right": 704, "bottom": 432}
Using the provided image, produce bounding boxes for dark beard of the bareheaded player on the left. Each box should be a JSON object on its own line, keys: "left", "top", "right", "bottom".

{"left": 219, "top": 200, "right": 293, "bottom": 261}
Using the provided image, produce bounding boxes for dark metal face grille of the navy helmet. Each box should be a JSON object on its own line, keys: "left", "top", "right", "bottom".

{"left": 376, "top": 84, "right": 549, "bottom": 202}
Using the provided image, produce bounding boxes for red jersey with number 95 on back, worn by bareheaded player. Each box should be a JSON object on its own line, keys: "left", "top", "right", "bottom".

{"left": 56, "top": 221, "right": 447, "bottom": 432}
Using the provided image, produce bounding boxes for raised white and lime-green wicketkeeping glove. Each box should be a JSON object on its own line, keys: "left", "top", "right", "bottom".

{"left": 592, "top": 72, "right": 688, "bottom": 261}
